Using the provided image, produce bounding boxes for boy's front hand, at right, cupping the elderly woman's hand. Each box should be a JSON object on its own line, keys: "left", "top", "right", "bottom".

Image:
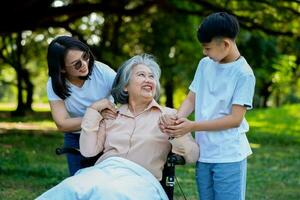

{"left": 164, "top": 118, "right": 193, "bottom": 137}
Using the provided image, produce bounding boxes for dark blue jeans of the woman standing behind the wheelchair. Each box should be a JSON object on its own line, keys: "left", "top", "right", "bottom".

{"left": 64, "top": 133, "right": 84, "bottom": 176}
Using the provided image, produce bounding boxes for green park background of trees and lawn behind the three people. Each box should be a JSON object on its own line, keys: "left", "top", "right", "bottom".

{"left": 0, "top": 0, "right": 300, "bottom": 200}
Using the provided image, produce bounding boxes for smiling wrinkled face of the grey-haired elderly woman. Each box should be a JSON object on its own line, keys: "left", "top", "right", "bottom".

{"left": 125, "top": 64, "right": 156, "bottom": 101}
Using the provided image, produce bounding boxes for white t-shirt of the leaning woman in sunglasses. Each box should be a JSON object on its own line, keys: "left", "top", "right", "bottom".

{"left": 47, "top": 61, "right": 116, "bottom": 117}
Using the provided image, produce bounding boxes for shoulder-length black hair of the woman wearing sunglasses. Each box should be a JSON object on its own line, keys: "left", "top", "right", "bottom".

{"left": 47, "top": 36, "right": 95, "bottom": 100}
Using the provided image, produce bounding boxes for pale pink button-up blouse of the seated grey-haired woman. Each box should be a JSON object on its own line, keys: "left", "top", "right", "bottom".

{"left": 80, "top": 100, "right": 199, "bottom": 180}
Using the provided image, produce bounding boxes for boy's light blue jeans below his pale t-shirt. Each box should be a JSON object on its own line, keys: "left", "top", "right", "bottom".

{"left": 196, "top": 159, "right": 247, "bottom": 200}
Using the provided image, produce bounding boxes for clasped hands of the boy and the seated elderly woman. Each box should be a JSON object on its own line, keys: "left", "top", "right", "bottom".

{"left": 159, "top": 114, "right": 193, "bottom": 137}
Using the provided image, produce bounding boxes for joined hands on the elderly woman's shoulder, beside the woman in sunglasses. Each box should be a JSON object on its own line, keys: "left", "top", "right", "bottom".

{"left": 90, "top": 99, "right": 118, "bottom": 119}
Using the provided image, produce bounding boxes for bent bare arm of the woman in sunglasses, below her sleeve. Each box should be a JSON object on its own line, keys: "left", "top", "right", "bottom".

{"left": 49, "top": 100, "right": 82, "bottom": 132}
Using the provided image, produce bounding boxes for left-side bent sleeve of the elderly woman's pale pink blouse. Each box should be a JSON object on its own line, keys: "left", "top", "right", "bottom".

{"left": 79, "top": 108, "right": 105, "bottom": 157}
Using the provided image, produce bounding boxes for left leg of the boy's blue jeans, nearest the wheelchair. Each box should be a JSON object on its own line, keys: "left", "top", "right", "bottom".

{"left": 196, "top": 161, "right": 214, "bottom": 200}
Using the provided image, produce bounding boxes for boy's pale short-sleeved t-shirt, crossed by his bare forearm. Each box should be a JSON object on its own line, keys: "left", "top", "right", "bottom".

{"left": 189, "top": 57, "right": 255, "bottom": 163}
